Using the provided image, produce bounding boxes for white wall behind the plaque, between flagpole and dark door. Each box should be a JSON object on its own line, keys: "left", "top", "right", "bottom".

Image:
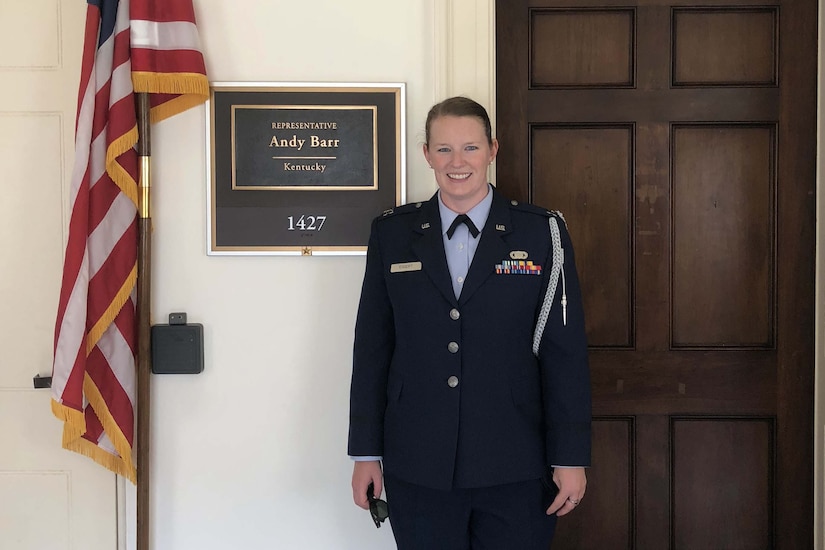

{"left": 130, "top": 0, "right": 493, "bottom": 550}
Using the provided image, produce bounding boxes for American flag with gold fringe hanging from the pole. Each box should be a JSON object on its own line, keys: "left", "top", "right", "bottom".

{"left": 52, "top": 0, "right": 209, "bottom": 482}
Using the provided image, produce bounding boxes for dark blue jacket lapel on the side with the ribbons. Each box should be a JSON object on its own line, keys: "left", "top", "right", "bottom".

{"left": 460, "top": 189, "right": 512, "bottom": 304}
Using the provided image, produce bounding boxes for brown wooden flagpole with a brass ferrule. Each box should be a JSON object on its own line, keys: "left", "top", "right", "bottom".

{"left": 135, "top": 93, "right": 152, "bottom": 550}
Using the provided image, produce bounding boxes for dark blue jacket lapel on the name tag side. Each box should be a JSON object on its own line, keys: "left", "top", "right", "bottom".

{"left": 412, "top": 195, "right": 456, "bottom": 304}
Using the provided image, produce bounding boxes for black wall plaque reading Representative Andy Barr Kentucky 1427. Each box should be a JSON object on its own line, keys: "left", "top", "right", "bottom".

{"left": 207, "top": 83, "right": 405, "bottom": 256}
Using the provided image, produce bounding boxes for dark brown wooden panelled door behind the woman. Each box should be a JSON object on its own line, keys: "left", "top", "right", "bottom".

{"left": 496, "top": 0, "right": 817, "bottom": 550}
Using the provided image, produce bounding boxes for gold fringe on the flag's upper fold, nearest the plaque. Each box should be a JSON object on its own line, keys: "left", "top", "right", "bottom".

{"left": 132, "top": 72, "right": 209, "bottom": 122}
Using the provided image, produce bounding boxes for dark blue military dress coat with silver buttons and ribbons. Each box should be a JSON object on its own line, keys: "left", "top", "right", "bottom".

{"left": 348, "top": 190, "right": 591, "bottom": 490}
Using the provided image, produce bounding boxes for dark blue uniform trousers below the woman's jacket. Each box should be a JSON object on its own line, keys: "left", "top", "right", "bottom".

{"left": 384, "top": 474, "right": 556, "bottom": 550}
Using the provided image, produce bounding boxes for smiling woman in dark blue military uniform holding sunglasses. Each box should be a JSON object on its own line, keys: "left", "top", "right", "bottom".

{"left": 349, "top": 97, "right": 590, "bottom": 550}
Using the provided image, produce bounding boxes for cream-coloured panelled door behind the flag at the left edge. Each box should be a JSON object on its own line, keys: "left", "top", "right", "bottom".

{"left": 0, "top": 0, "right": 118, "bottom": 550}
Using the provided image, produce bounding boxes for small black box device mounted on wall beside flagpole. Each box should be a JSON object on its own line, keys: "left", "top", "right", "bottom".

{"left": 152, "top": 313, "right": 203, "bottom": 374}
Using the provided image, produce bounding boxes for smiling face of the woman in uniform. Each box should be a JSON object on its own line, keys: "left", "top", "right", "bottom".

{"left": 424, "top": 115, "right": 498, "bottom": 214}
